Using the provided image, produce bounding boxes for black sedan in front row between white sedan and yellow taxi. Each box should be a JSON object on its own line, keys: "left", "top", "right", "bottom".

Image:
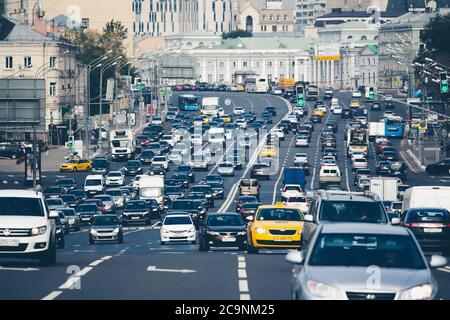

{"left": 199, "top": 213, "right": 247, "bottom": 251}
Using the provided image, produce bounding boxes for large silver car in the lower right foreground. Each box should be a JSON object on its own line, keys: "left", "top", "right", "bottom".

{"left": 286, "top": 223, "right": 447, "bottom": 300}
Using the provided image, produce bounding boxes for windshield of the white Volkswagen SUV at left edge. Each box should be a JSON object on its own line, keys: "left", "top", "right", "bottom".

{"left": 0, "top": 197, "right": 44, "bottom": 217}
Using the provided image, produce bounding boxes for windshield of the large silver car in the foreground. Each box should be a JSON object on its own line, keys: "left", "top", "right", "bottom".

{"left": 308, "top": 234, "right": 426, "bottom": 269}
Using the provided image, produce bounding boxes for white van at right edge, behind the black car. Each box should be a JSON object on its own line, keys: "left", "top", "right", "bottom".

{"left": 402, "top": 186, "right": 450, "bottom": 212}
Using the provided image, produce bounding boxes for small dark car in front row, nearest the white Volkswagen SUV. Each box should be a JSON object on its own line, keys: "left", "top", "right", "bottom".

{"left": 89, "top": 214, "right": 123, "bottom": 244}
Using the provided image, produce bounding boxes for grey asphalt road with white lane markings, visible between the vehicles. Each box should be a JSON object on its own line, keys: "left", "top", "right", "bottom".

{"left": 0, "top": 92, "right": 450, "bottom": 300}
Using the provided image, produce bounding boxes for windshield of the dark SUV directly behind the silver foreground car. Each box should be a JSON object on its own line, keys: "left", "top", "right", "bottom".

{"left": 319, "top": 200, "right": 387, "bottom": 223}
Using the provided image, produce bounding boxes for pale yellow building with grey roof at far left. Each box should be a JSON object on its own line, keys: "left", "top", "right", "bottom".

{"left": 0, "top": 17, "right": 78, "bottom": 139}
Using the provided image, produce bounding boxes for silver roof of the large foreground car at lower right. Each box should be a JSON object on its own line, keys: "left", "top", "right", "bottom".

{"left": 321, "top": 222, "right": 409, "bottom": 236}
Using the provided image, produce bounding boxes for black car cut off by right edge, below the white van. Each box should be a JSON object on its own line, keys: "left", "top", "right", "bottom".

{"left": 401, "top": 208, "right": 450, "bottom": 255}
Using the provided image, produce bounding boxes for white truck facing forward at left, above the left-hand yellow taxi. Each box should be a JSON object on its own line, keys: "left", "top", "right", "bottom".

{"left": 109, "top": 129, "right": 136, "bottom": 161}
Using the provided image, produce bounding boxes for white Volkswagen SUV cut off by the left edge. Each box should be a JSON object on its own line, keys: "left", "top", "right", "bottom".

{"left": 0, "top": 190, "right": 58, "bottom": 265}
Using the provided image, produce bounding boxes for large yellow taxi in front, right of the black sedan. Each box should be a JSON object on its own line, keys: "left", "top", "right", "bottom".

{"left": 247, "top": 202, "right": 303, "bottom": 253}
